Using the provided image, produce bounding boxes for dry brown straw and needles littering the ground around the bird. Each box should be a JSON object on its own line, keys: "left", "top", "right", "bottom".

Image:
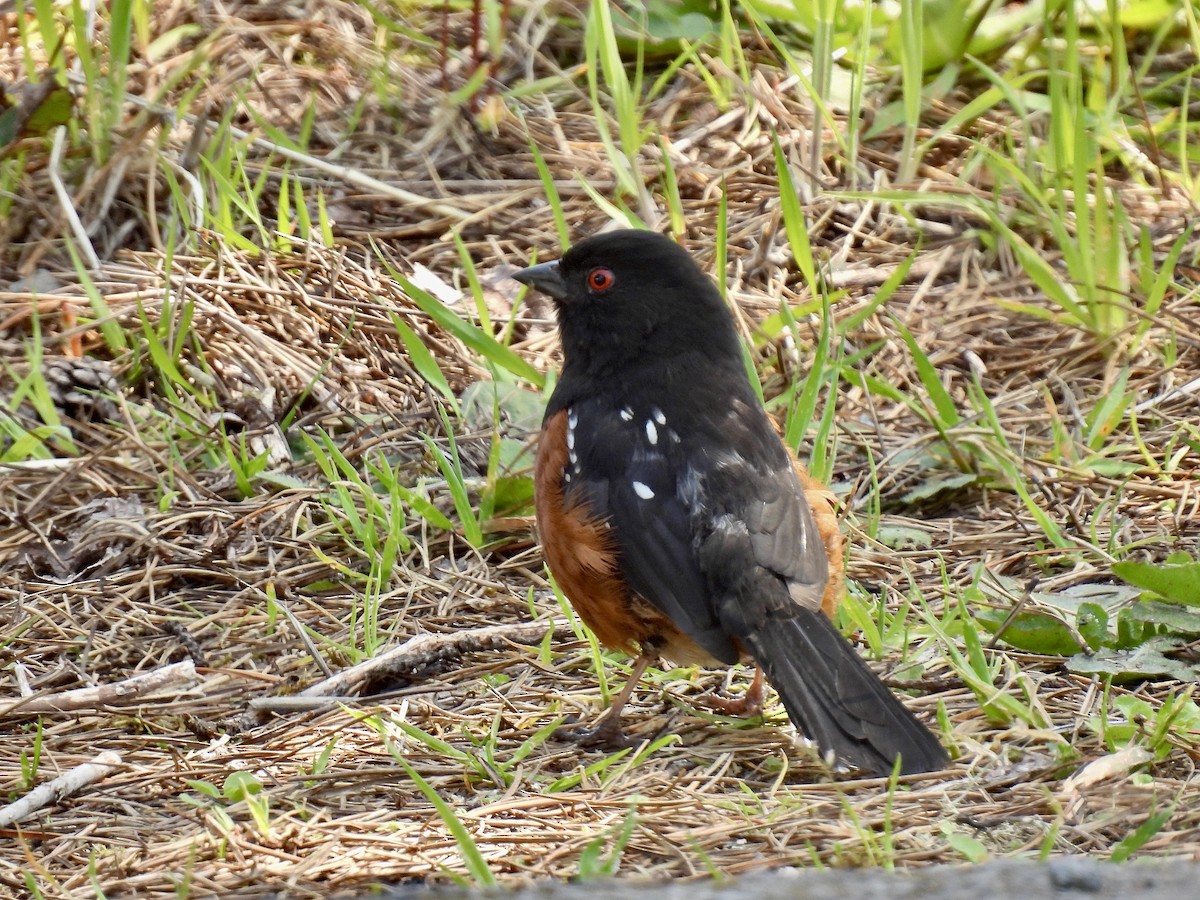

{"left": 0, "top": 0, "right": 1200, "bottom": 896}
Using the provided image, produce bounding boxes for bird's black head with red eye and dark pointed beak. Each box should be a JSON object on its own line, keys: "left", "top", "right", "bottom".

{"left": 512, "top": 230, "right": 742, "bottom": 373}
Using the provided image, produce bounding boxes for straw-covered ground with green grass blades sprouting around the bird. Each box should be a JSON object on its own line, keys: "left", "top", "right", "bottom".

{"left": 0, "top": 0, "right": 1200, "bottom": 896}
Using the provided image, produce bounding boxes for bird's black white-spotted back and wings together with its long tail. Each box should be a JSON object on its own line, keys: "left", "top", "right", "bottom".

{"left": 564, "top": 400, "right": 947, "bottom": 773}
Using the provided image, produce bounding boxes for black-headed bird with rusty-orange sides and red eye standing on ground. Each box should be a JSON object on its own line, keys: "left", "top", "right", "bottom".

{"left": 512, "top": 229, "right": 949, "bottom": 775}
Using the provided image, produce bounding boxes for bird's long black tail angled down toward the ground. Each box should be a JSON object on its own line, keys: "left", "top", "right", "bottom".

{"left": 744, "top": 608, "right": 949, "bottom": 775}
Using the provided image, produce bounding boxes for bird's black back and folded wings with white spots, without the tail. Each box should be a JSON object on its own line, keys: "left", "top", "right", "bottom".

{"left": 565, "top": 398, "right": 828, "bottom": 662}
